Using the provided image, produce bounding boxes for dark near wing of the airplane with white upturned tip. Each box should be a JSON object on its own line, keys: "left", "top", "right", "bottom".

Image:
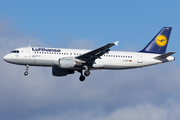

{"left": 76, "top": 41, "right": 119, "bottom": 64}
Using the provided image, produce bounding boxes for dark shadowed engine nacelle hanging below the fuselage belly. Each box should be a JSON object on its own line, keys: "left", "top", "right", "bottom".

{"left": 52, "top": 67, "right": 74, "bottom": 76}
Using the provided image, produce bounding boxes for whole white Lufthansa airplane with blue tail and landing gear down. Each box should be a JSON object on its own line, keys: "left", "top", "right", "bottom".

{"left": 3, "top": 27, "right": 175, "bottom": 81}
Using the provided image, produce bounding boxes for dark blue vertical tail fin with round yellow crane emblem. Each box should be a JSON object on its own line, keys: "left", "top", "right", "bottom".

{"left": 140, "top": 27, "right": 172, "bottom": 54}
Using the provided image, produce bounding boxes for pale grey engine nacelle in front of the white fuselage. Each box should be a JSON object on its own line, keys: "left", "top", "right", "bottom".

{"left": 59, "top": 58, "right": 76, "bottom": 68}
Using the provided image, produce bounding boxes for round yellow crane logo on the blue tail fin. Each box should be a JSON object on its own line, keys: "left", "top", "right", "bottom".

{"left": 156, "top": 35, "right": 167, "bottom": 47}
